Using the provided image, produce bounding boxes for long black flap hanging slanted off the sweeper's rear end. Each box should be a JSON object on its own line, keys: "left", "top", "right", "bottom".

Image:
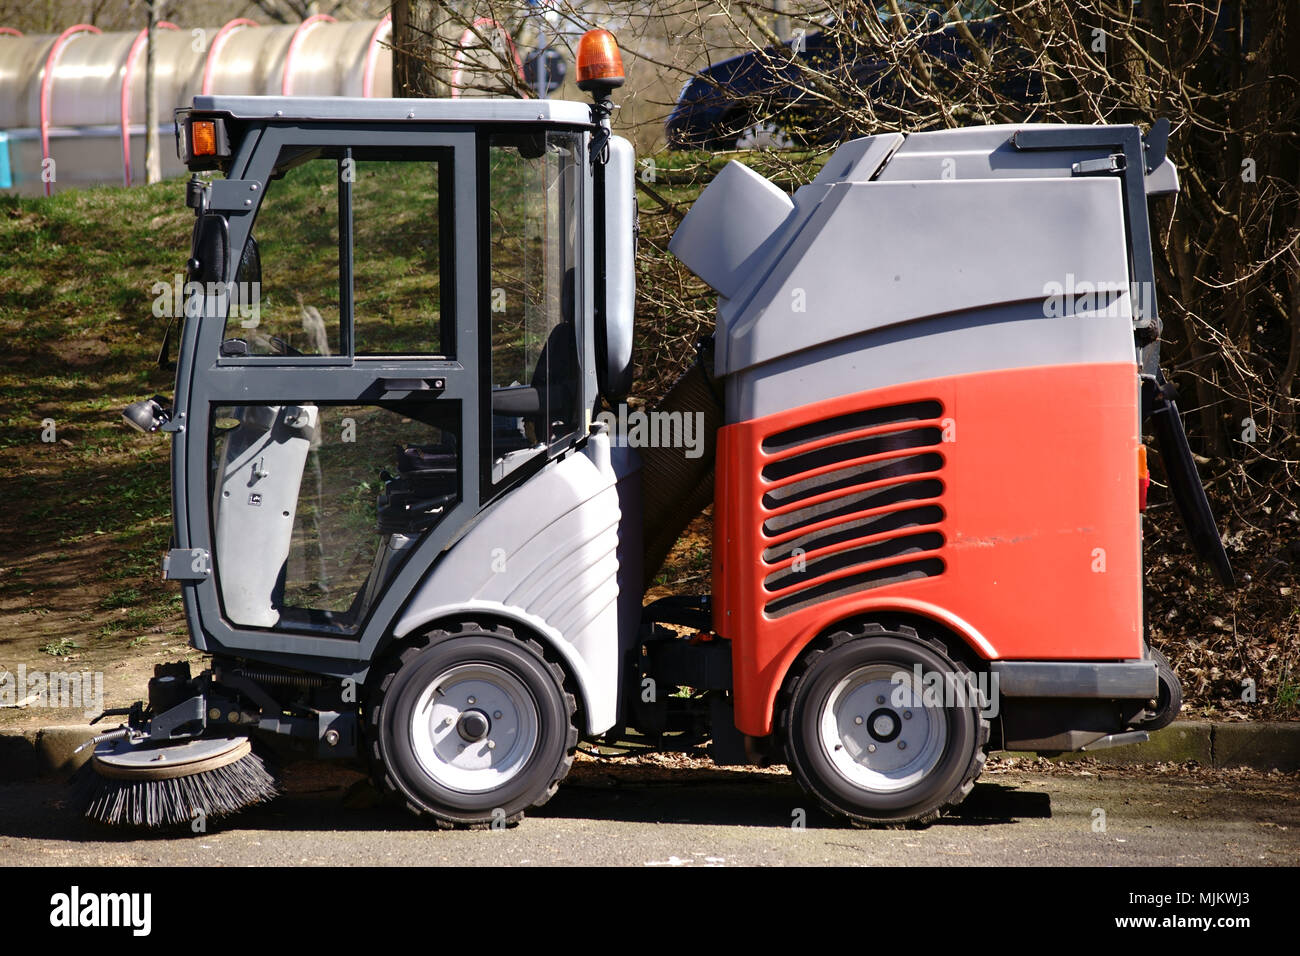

{"left": 1143, "top": 368, "right": 1236, "bottom": 588}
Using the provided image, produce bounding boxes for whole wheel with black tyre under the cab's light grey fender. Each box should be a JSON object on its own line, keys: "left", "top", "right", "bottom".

{"left": 365, "top": 622, "right": 577, "bottom": 827}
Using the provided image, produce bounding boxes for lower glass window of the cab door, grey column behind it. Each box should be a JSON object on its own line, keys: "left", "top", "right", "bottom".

{"left": 209, "top": 402, "right": 460, "bottom": 632}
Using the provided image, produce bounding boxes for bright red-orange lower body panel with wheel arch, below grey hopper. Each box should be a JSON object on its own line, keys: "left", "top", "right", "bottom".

{"left": 714, "top": 363, "right": 1141, "bottom": 736}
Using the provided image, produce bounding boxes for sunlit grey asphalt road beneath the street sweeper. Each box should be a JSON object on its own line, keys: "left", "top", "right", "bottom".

{"left": 0, "top": 761, "right": 1300, "bottom": 866}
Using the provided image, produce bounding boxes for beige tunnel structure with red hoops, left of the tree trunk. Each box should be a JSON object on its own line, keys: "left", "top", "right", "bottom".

{"left": 0, "top": 14, "right": 393, "bottom": 195}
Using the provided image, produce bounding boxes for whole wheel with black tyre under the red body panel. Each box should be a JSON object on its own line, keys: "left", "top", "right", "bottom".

{"left": 779, "top": 623, "right": 989, "bottom": 826}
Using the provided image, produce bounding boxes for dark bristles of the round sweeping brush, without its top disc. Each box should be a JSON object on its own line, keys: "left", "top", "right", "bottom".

{"left": 73, "top": 753, "right": 280, "bottom": 827}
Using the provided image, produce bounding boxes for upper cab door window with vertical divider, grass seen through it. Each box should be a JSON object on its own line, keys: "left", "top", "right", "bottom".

{"left": 221, "top": 147, "right": 454, "bottom": 358}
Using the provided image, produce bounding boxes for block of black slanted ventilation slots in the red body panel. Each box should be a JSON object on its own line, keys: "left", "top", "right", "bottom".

{"left": 762, "top": 401, "right": 945, "bottom": 617}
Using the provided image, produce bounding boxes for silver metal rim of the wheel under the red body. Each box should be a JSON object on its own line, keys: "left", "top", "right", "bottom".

{"left": 818, "top": 663, "right": 948, "bottom": 793}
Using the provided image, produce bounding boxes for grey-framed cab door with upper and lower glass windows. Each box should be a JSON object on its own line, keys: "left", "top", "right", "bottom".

{"left": 173, "top": 125, "right": 481, "bottom": 671}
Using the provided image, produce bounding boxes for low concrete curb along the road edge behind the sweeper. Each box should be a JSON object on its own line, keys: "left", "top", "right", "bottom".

{"left": 0, "top": 721, "right": 1300, "bottom": 783}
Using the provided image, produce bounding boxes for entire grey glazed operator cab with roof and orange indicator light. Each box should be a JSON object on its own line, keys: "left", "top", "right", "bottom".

{"left": 169, "top": 96, "right": 631, "bottom": 656}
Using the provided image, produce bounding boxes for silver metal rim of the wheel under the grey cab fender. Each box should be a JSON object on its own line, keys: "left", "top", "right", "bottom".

{"left": 411, "top": 663, "right": 541, "bottom": 793}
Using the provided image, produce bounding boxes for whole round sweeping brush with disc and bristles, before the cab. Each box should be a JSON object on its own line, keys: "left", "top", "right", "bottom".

{"left": 73, "top": 737, "right": 280, "bottom": 827}
